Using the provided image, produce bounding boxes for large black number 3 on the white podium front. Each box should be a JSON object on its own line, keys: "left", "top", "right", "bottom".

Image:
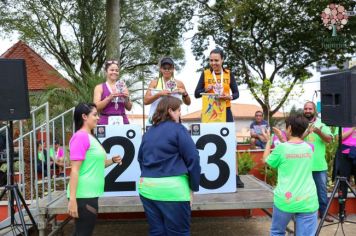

{"left": 196, "top": 134, "right": 230, "bottom": 189}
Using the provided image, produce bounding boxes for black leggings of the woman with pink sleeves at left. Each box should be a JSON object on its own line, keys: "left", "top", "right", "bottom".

{"left": 72, "top": 197, "right": 98, "bottom": 236}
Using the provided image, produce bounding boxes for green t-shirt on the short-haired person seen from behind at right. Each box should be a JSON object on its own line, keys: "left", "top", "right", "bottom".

{"left": 266, "top": 142, "right": 319, "bottom": 213}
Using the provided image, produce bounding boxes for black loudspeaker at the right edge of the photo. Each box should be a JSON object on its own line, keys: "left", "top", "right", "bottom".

{"left": 320, "top": 69, "right": 356, "bottom": 127}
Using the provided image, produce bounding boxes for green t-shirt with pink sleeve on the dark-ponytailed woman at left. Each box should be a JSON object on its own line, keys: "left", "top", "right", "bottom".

{"left": 67, "top": 131, "right": 106, "bottom": 198}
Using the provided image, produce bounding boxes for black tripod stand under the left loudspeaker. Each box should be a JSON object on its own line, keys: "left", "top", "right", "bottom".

{"left": 0, "top": 121, "right": 38, "bottom": 236}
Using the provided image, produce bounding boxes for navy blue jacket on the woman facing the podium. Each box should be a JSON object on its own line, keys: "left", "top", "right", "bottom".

{"left": 138, "top": 121, "right": 201, "bottom": 191}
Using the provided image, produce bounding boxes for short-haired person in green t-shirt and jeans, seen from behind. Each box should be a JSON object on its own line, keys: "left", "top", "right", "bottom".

{"left": 263, "top": 115, "right": 319, "bottom": 235}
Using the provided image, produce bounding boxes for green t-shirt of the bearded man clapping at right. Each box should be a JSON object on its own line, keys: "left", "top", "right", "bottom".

{"left": 304, "top": 119, "right": 332, "bottom": 171}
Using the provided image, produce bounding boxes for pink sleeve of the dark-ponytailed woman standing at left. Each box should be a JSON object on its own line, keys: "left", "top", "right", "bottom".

{"left": 69, "top": 130, "right": 90, "bottom": 161}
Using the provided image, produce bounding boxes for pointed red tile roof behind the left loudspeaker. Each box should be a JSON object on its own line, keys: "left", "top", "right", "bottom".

{"left": 0, "top": 41, "right": 69, "bottom": 91}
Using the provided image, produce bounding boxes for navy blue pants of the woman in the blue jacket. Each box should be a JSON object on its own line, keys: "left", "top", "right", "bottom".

{"left": 140, "top": 195, "right": 191, "bottom": 236}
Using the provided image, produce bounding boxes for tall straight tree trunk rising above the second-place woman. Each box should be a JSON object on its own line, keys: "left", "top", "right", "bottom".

{"left": 106, "top": 0, "right": 120, "bottom": 64}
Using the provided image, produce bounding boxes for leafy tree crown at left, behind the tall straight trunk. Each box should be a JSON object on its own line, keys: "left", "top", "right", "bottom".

{"left": 0, "top": 0, "right": 194, "bottom": 111}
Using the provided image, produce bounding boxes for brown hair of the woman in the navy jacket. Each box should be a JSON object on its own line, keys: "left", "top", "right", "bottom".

{"left": 152, "top": 96, "right": 182, "bottom": 125}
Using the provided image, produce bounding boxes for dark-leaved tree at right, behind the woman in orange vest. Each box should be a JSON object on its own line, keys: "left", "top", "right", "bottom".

{"left": 193, "top": 0, "right": 355, "bottom": 121}
